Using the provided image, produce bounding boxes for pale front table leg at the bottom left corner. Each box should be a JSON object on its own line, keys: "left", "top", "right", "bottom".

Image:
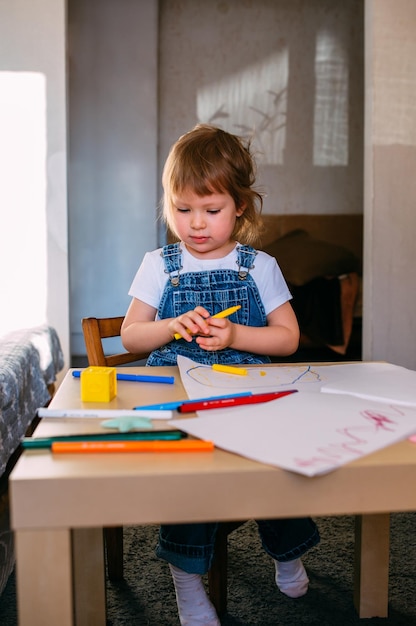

{"left": 15, "top": 529, "right": 73, "bottom": 626}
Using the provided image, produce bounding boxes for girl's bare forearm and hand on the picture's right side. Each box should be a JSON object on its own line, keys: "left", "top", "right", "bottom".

{"left": 196, "top": 302, "right": 300, "bottom": 356}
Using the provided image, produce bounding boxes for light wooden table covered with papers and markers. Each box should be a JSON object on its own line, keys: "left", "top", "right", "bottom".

{"left": 10, "top": 367, "right": 416, "bottom": 626}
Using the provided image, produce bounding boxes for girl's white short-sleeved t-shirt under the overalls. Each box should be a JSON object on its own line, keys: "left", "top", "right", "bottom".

{"left": 129, "top": 244, "right": 292, "bottom": 315}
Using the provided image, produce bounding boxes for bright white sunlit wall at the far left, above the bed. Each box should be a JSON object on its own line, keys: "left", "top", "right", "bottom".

{"left": 0, "top": 0, "right": 69, "bottom": 365}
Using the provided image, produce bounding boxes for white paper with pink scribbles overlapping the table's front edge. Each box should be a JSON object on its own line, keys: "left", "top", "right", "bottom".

{"left": 170, "top": 391, "right": 416, "bottom": 476}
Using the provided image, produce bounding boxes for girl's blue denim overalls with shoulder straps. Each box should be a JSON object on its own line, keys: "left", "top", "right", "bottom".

{"left": 152, "top": 243, "right": 319, "bottom": 574}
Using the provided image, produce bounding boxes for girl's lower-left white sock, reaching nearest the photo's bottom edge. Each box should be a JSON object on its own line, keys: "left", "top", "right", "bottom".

{"left": 169, "top": 564, "right": 220, "bottom": 626}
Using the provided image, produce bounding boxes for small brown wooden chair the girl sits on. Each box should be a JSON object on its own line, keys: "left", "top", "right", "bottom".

{"left": 82, "top": 316, "right": 244, "bottom": 615}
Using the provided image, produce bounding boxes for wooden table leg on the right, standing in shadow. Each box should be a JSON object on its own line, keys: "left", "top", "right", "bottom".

{"left": 354, "top": 513, "right": 390, "bottom": 618}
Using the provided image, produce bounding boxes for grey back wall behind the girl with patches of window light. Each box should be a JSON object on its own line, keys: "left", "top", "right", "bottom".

{"left": 68, "top": 0, "right": 363, "bottom": 354}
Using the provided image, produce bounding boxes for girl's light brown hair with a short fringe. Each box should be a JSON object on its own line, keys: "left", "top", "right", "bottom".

{"left": 162, "top": 124, "right": 263, "bottom": 244}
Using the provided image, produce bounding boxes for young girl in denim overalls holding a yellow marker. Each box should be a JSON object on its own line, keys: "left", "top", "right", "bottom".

{"left": 121, "top": 125, "right": 319, "bottom": 626}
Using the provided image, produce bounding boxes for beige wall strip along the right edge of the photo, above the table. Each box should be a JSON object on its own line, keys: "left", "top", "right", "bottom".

{"left": 363, "top": 0, "right": 416, "bottom": 369}
